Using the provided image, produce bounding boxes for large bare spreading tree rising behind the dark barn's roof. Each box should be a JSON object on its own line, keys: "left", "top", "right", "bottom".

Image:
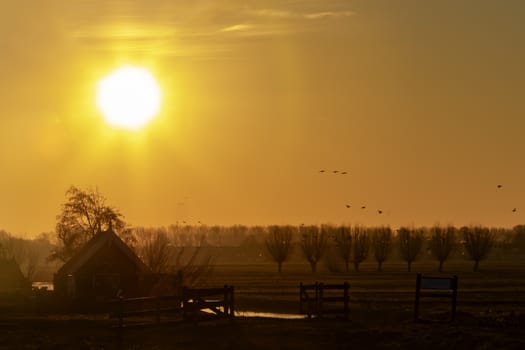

{"left": 50, "top": 186, "right": 133, "bottom": 261}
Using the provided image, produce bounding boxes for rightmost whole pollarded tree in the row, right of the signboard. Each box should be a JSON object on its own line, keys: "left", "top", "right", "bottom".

{"left": 460, "top": 226, "right": 494, "bottom": 272}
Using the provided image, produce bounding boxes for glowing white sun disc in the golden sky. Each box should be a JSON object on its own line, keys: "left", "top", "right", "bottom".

{"left": 96, "top": 66, "right": 162, "bottom": 129}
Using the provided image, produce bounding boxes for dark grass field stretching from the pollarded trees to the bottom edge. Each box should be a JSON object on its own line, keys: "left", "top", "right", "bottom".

{"left": 0, "top": 260, "right": 525, "bottom": 350}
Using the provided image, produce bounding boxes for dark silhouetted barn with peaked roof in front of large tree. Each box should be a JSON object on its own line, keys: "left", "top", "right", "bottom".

{"left": 53, "top": 229, "right": 152, "bottom": 301}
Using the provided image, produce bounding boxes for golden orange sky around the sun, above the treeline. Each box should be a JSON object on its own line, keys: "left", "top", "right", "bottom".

{"left": 0, "top": 0, "right": 525, "bottom": 235}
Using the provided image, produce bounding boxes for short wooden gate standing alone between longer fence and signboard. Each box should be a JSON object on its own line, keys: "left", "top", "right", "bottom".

{"left": 299, "top": 281, "right": 350, "bottom": 320}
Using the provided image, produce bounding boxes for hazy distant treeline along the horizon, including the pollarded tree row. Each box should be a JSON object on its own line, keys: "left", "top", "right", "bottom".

{"left": 0, "top": 224, "right": 525, "bottom": 281}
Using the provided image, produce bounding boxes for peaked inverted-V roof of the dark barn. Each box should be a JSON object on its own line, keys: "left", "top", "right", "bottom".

{"left": 57, "top": 229, "right": 151, "bottom": 275}
